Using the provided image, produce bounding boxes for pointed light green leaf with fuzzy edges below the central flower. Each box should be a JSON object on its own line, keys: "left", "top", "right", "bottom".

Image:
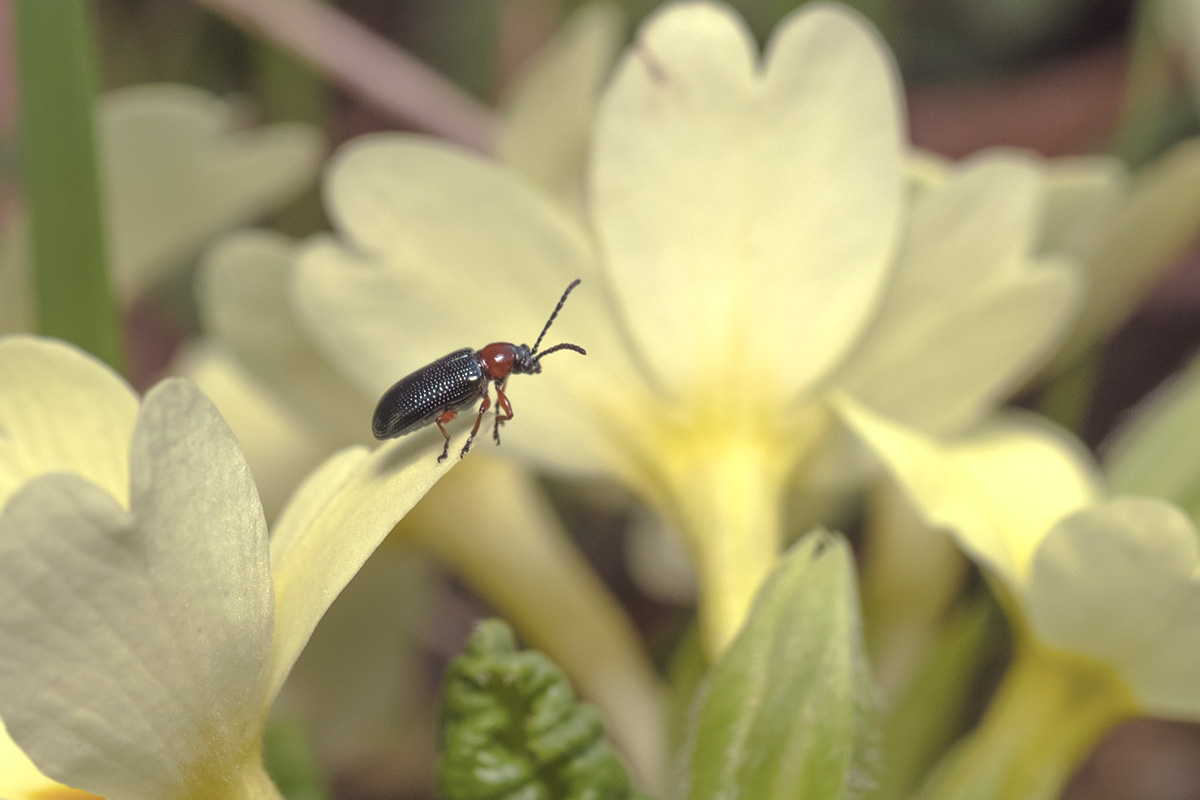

{"left": 680, "top": 530, "right": 871, "bottom": 800}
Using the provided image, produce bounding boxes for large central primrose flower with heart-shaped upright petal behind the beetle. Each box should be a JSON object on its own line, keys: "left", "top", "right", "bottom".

{"left": 294, "top": 2, "right": 1078, "bottom": 652}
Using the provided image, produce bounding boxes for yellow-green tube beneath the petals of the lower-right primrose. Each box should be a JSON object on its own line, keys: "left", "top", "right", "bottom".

{"left": 918, "top": 642, "right": 1138, "bottom": 800}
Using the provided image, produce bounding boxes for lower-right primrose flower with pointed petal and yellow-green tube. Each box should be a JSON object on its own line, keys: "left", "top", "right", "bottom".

{"left": 839, "top": 398, "right": 1200, "bottom": 799}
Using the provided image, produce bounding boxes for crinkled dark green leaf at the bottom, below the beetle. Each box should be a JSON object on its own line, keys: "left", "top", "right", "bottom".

{"left": 437, "top": 620, "right": 637, "bottom": 800}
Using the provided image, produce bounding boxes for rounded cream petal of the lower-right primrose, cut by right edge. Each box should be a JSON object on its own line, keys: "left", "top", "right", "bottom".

{"left": 1028, "top": 497, "right": 1200, "bottom": 721}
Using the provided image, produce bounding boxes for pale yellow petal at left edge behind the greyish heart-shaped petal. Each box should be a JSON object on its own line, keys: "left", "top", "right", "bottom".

{"left": 0, "top": 336, "right": 138, "bottom": 507}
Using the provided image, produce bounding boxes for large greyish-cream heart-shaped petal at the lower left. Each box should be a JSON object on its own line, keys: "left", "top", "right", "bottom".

{"left": 0, "top": 380, "right": 271, "bottom": 799}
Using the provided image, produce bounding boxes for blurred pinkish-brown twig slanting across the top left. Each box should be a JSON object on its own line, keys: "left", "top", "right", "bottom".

{"left": 196, "top": 0, "right": 497, "bottom": 152}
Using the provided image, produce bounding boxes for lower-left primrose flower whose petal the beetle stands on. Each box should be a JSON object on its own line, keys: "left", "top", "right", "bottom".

{"left": 0, "top": 337, "right": 446, "bottom": 800}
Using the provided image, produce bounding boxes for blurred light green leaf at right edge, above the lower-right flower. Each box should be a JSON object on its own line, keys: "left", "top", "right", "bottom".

{"left": 1104, "top": 350, "right": 1200, "bottom": 518}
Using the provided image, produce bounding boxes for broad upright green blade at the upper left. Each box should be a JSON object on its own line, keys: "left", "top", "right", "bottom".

{"left": 14, "top": 0, "right": 125, "bottom": 369}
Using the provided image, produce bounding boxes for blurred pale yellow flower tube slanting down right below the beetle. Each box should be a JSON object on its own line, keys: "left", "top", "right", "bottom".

{"left": 408, "top": 453, "right": 666, "bottom": 792}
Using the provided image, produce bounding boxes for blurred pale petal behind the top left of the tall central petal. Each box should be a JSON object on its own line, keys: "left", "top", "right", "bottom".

{"left": 497, "top": 1, "right": 625, "bottom": 204}
